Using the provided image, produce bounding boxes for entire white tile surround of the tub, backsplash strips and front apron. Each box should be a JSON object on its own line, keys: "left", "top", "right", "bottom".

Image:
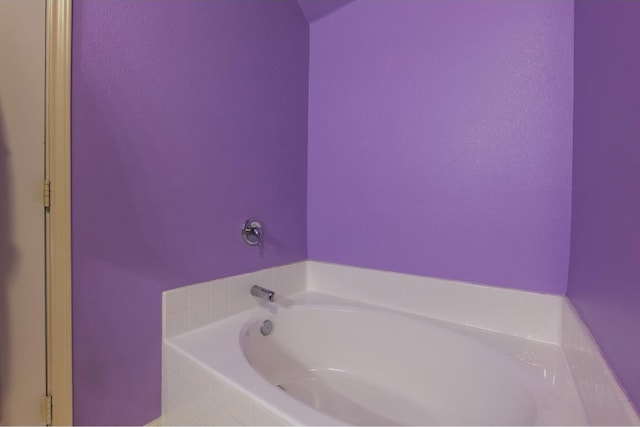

{"left": 162, "top": 261, "right": 640, "bottom": 425}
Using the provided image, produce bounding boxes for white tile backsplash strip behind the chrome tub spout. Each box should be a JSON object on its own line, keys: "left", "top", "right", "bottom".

{"left": 162, "top": 262, "right": 306, "bottom": 338}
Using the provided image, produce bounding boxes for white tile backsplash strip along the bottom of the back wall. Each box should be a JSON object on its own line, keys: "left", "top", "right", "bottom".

{"left": 307, "top": 261, "right": 564, "bottom": 344}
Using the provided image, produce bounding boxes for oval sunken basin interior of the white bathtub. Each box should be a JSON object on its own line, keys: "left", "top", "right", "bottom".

{"left": 242, "top": 306, "right": 544, "bottom": 425}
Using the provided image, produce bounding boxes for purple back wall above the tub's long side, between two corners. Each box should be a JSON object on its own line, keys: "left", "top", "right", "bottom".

{"left": 307, "top": 0, "right": 573, "bottom": 294}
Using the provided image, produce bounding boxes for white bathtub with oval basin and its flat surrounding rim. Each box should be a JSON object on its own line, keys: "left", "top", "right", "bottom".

{"left": 171, "top": 292, "right": 587, "bottom": 425}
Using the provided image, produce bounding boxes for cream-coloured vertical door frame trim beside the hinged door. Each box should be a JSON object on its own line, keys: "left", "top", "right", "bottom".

{"left": 45, "top": 0, "right": 73, "bottom": 425}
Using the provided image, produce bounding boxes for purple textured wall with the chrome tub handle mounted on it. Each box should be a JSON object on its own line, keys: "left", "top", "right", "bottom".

{"left": 72, "top": 0, "right": 309, "bottom": 425}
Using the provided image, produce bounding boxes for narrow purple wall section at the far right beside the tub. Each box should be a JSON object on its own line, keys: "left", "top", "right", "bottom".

{"left": 568, "top": 0, "right": 640, "bottom": 407}
